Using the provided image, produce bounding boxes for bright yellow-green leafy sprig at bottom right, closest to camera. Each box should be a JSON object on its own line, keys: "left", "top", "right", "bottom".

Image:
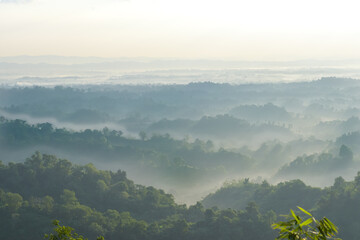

{"left": 272, "top": 207, "right": 341, "bottom": 240}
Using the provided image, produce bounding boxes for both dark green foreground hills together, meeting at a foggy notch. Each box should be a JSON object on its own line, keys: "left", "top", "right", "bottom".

{"left": 0, "top": 152, "right": 360, "bottom": 240}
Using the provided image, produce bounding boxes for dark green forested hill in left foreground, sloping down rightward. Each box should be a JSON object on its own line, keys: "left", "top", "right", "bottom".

{"left": 0, "top": 152, "right": 276, "bottom": 240}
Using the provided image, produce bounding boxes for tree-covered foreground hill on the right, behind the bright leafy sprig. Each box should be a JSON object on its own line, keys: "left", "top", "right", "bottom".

{"left": 202, "top": 172, "right": 360, "bottom": 240}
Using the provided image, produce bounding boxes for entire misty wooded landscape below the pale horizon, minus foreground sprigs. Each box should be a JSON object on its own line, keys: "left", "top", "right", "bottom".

{"left": 0, "top": 78, "right": 360, "bottom": 240}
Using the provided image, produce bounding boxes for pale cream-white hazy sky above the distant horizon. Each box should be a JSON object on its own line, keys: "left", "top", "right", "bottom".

{"left": 0, "top": 0, "right": 360, "bottom": 60}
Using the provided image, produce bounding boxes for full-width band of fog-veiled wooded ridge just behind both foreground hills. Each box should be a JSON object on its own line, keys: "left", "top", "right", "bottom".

{"left": 0, "top": 117, "right": 360, "bottom": 203}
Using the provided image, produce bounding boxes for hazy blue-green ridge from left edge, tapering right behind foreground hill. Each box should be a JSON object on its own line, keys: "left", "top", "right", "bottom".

{"left": 0, "top": 118, "right": 256, "bottom": 201}
